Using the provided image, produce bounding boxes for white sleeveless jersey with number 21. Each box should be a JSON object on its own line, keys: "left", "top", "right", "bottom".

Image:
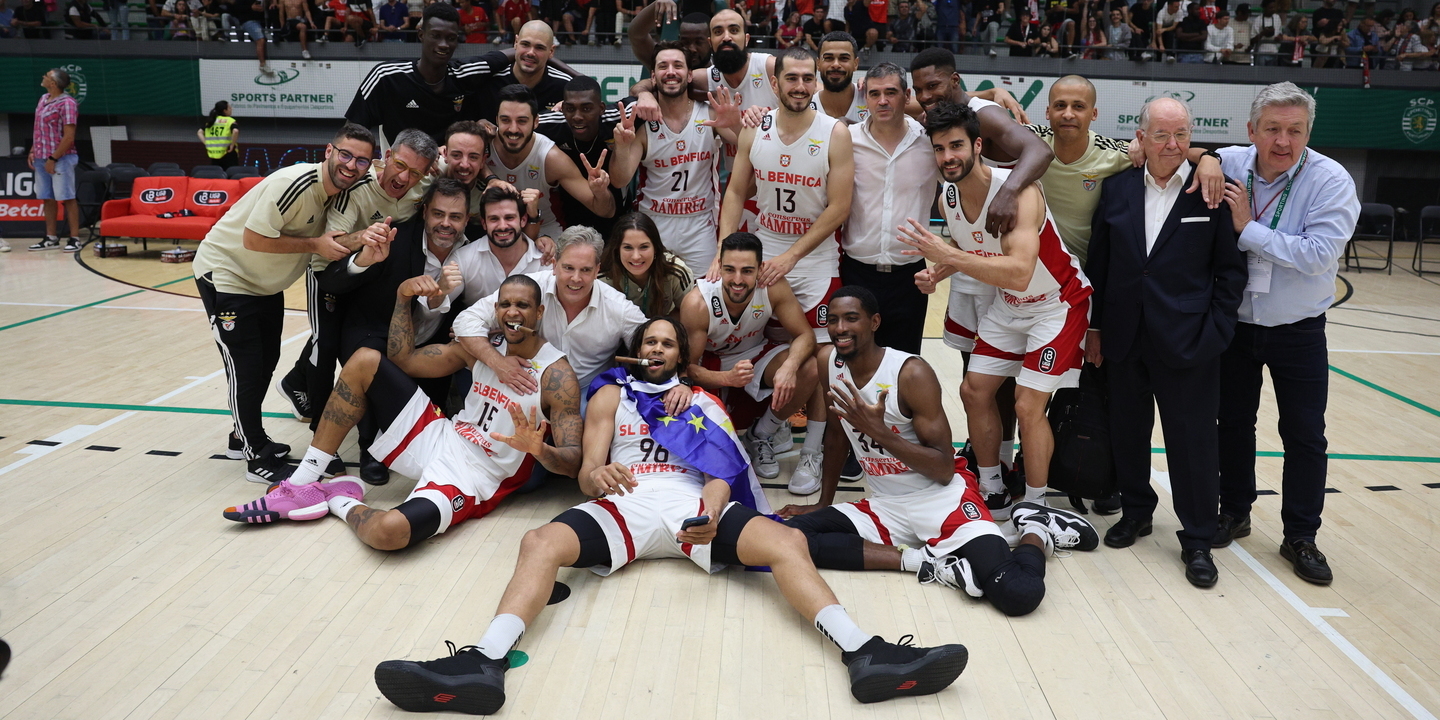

{"left": 636, "top": 102, "right": 723, "bottom": 216}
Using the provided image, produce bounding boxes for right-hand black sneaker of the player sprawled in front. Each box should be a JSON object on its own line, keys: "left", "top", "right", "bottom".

{"left": 840, "top": 635, "right": 971, "bottom": 703}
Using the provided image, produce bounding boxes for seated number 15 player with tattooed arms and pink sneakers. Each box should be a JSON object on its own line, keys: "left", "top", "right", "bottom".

{"left": 225, "top": 275, "right": 580, "bottom": 550}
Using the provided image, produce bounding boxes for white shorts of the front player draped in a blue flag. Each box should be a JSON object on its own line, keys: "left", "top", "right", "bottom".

{"left": 575, "top": 482, "right": 739, "bottom": 576}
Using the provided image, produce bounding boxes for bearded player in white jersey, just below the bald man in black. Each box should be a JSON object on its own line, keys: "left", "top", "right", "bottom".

{"left": 485, "top": 85, "right": 615, "bottom": 250}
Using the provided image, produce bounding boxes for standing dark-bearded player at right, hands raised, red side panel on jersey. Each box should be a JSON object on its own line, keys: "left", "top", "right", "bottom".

{"left": 900, "top": 102, "right": 1090, "bottom": 517}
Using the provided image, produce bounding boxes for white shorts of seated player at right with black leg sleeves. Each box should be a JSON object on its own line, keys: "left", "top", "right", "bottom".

{"left": 834, "top": 474, "right": 1005, "bottom": 556}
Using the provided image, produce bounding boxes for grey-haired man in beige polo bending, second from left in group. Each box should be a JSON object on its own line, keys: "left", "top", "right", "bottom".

{"left": 275, "top": 128, "right": 436, "bottom": 484}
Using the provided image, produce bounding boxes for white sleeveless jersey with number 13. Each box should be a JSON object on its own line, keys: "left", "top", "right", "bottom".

{"left": 750, "top": 111, "right": 840, "bottom": 278}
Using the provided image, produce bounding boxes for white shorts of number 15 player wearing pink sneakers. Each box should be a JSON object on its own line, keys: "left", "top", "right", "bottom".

{"left": 370, "top": 390, "right": 534, "bottom": 534}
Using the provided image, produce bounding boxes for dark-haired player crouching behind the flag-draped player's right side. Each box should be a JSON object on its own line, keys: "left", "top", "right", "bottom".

{"left": 680, "top": 232, "right": 825, "bottom": 495}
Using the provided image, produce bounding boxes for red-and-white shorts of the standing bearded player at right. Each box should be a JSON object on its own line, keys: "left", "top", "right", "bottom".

{"left": 968, "top": 298, "right": 1090, "bottom": 393}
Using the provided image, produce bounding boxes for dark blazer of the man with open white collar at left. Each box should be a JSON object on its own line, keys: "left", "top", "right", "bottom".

{"left": 320, "top": 213, "right": 455, "bottom": 359}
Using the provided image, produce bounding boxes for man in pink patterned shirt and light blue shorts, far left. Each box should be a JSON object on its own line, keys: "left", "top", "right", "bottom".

{"left": 29, "top": 68, "right": 81, "bottom": 252}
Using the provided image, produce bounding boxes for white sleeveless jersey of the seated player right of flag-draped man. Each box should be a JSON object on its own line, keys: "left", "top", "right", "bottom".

{"left": 829, "top": 347, "right": 937, "bottom": 497}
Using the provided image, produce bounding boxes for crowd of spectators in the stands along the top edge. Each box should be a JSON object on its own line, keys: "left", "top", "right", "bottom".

{"left": 0, "top": 0, "right": 1440, "bottom": 71}
